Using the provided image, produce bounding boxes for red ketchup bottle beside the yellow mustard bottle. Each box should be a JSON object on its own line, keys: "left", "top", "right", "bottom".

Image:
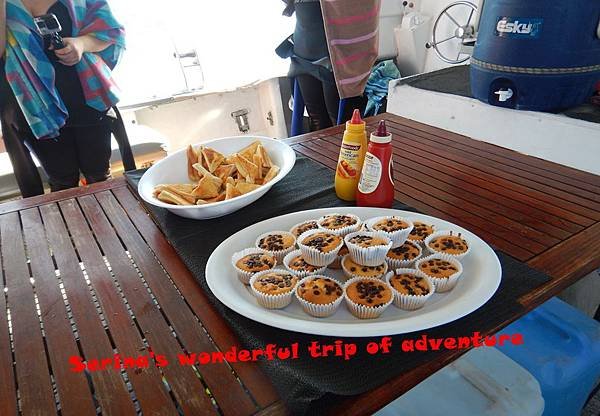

{"left": 356, "top": 120, "right": 394, "bottom": 208}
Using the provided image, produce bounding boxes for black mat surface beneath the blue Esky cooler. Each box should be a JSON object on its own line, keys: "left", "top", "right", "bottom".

{"left": 400, "top": 65, "right": 600, "bottom": 123}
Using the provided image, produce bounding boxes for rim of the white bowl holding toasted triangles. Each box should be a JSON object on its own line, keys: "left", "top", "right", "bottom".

{"left": 138, "top": 136, "right": 295, "bottom": 211}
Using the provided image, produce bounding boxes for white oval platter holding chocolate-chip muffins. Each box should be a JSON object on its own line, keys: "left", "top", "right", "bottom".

{"left": 206, "top": 207, "right": 502, "bottom": 337}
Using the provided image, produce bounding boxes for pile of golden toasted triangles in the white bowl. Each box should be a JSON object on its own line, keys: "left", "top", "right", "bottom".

{"left": 154, "top": 140, "right": 279, "bottom": 205}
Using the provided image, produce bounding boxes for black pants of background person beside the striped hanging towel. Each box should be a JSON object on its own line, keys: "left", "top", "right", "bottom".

{"left": 296, "top": 74, "right": 366, "bottom": 131}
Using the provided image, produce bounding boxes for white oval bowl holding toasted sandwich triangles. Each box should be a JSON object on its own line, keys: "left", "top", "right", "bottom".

{"left": 138, "top": 136, "right": 296, "bottom": 220}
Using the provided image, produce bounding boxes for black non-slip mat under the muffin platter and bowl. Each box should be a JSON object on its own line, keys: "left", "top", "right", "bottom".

{"left": 127, "top": 156, "right": 549, "bottom": 414}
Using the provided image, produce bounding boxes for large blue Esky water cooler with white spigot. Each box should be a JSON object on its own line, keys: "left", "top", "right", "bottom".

{"left": 471, "top": 0, "right": 600, "bottom": 111}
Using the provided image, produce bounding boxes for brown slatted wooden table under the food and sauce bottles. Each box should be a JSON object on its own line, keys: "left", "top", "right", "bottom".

{"left": 0, "top": 114, "right": 600, "bottom": 415}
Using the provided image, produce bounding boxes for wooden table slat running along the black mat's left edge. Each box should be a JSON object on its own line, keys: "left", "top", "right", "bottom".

{"left": 113, "top": 188, "right": 278, "bottom": 404}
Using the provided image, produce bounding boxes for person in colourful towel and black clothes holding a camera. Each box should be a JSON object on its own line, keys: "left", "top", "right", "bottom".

{"left": 0, "top": 0, "right": 124, "bottom": 196}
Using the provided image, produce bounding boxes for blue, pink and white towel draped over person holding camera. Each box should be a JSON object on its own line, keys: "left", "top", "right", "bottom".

{"left": 5, "top": 0, "right": 125, "bottom": 139}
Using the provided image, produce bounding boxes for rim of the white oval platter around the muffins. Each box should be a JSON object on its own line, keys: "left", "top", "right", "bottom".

{"left": 205, "top": 207, "right": 502, "bottom": 337}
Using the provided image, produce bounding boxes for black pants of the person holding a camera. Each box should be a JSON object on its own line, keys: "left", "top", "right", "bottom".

{"left": 27, "top": 116, "right": 111, "bottom": 192}
